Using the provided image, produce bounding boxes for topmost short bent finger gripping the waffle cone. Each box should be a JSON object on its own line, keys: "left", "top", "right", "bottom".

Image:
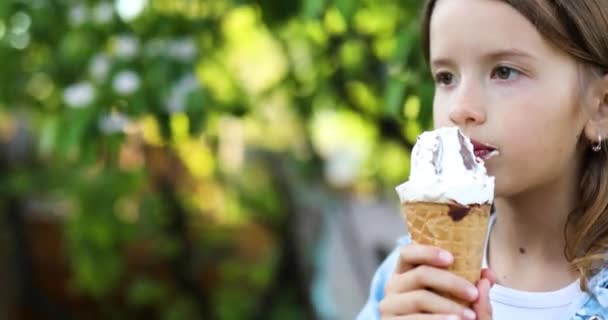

{"left": 395, "top": 244, "right": 454, "bottom": 273}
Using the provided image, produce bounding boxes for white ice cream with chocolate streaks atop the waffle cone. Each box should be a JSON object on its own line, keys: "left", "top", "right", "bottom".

{"left": 396, "top": 127, "right": 494, "bottom": 206}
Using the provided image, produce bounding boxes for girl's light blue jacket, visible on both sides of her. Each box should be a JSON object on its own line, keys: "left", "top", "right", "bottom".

{"left": 357, "top": 237, "right": 608, "bottom": 320}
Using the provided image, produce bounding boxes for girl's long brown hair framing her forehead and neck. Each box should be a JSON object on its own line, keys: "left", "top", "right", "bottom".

{"left": 422, "top": 0, "right": 608, "bottom": 290}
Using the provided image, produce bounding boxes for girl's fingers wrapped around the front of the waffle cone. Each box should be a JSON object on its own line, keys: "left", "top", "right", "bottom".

{"left": 380, "top": 244, "right": 480, "bottom": 320}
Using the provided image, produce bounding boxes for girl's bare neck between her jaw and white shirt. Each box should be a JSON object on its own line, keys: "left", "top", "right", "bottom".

{"left": 489, "top": 170, "right": 577, "bottom": 291}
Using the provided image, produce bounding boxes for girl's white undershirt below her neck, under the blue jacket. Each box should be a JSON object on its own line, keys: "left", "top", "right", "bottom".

{"left": 483, "top": 214, "right": 584, "bottom": 320}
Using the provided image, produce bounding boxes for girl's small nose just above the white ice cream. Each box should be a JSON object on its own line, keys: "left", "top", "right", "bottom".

{"left": 450, "top": 86, "right": 486, "bottom": 127}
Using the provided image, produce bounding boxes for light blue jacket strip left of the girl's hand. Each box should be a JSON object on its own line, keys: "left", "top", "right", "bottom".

{"left": 357, "top": 236, "right": 411, "bottom": 320}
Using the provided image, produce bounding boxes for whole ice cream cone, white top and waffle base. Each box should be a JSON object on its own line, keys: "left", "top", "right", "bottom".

{"left": 396, "top": 127, "right": 499, "bottom": 305}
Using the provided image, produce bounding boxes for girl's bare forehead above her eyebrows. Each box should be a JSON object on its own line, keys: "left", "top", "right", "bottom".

{"left": 430, "top": 0, "right": 556, "bottom": 58}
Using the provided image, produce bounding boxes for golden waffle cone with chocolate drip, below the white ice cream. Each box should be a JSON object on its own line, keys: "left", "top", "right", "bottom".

{"left": 403, "top": 202, "right": 491, "bottom": 302}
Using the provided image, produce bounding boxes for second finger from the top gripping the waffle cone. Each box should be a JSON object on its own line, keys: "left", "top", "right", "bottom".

{"left": 384, "top": 265, "right": 479, "bottom": 302}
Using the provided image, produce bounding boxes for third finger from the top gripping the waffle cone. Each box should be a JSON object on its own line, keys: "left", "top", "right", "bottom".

{"left": 380, "top": 290, "right": 475, "bottom": 320}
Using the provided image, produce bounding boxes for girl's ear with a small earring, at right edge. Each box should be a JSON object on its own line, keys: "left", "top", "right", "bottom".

{"left": 584, "top": 74, "right": 608, "bottom": 142}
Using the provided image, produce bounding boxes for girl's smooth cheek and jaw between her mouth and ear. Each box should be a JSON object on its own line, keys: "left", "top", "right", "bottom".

{"left": 488, "top": 99, "right": 582, "bottom": 196}
